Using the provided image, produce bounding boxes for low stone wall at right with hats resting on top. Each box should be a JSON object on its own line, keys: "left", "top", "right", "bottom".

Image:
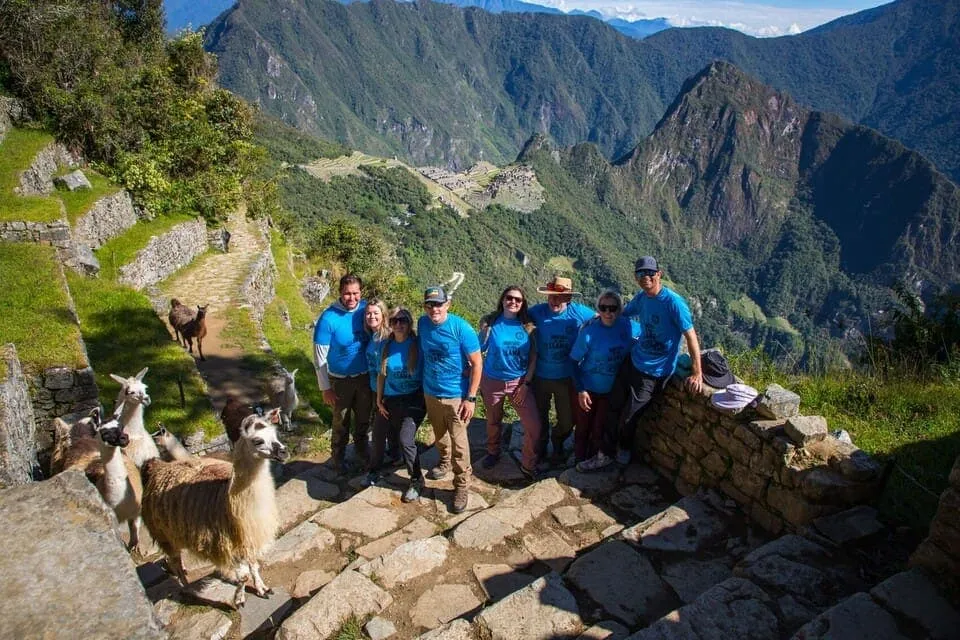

{"left": 638, "top": 378, "right": 883, "bottom": 534}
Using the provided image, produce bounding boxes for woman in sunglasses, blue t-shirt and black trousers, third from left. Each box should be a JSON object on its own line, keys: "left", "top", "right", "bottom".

{"left": 371, "top": 307, "right": 427, "bottom": 502}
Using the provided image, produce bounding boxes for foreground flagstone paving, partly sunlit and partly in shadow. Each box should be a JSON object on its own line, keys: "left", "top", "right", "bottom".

{"left": 140, "top": 421, "right": 960, "bottom": 640}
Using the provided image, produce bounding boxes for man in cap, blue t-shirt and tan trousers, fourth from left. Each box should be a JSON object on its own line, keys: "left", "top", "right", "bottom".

{"left": 417, "top": 287, "right": 483, "bottom": 513}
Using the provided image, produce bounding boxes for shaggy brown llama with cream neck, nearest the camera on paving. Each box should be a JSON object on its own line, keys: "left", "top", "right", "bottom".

{"left": 142, "top": 408, "right": 287, "bottom": 607}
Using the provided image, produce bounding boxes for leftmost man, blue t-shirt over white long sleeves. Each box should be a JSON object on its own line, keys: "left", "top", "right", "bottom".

{"left": 313, "top": 274, "right": 374, "bottom": 474}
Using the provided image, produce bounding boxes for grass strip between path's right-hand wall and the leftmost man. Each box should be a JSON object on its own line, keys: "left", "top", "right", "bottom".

{"left": 263, "top": 231, "right": 331, "bottom": 435}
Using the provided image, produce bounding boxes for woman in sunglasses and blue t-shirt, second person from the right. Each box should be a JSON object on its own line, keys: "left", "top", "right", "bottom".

{"left": 570, "top": 291, "right": 640, "bottom": 463}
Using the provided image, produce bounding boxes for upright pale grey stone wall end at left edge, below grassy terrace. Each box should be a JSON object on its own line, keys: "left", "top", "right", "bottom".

{"left": 0, "top": 344, "right": 39, "bottom": 489}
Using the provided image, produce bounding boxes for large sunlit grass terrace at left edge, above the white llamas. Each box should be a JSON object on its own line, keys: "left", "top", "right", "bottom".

{"left": 0, "top": 243, "right": 87, "bottom": 374}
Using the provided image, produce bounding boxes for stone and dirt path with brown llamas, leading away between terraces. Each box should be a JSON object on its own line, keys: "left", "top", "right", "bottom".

{"left": 162, "top": 210, "right": 264, "bottom": 410}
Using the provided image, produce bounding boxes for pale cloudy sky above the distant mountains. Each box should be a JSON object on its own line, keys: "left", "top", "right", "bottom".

{"left": 529, "top": 0, "right": 887, "bottom": 36}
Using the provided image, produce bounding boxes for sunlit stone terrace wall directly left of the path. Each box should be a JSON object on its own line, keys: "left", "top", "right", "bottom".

{"left": 118, "top": 218, "right": 207, "bottom": 291}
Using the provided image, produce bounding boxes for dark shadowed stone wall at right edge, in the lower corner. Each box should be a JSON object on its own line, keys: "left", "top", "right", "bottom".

{"left": 910, "top": 457, "right": 960, "bottom": 605}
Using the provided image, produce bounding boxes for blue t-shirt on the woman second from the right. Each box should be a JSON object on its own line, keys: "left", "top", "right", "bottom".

{"left": 570, "top": 316, "right": 640, "bottom": 393}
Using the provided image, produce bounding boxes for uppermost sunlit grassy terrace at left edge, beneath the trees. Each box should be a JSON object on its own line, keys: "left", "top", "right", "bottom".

{"left": 0, "top": 129, "right": 60, "bottom": 222}
